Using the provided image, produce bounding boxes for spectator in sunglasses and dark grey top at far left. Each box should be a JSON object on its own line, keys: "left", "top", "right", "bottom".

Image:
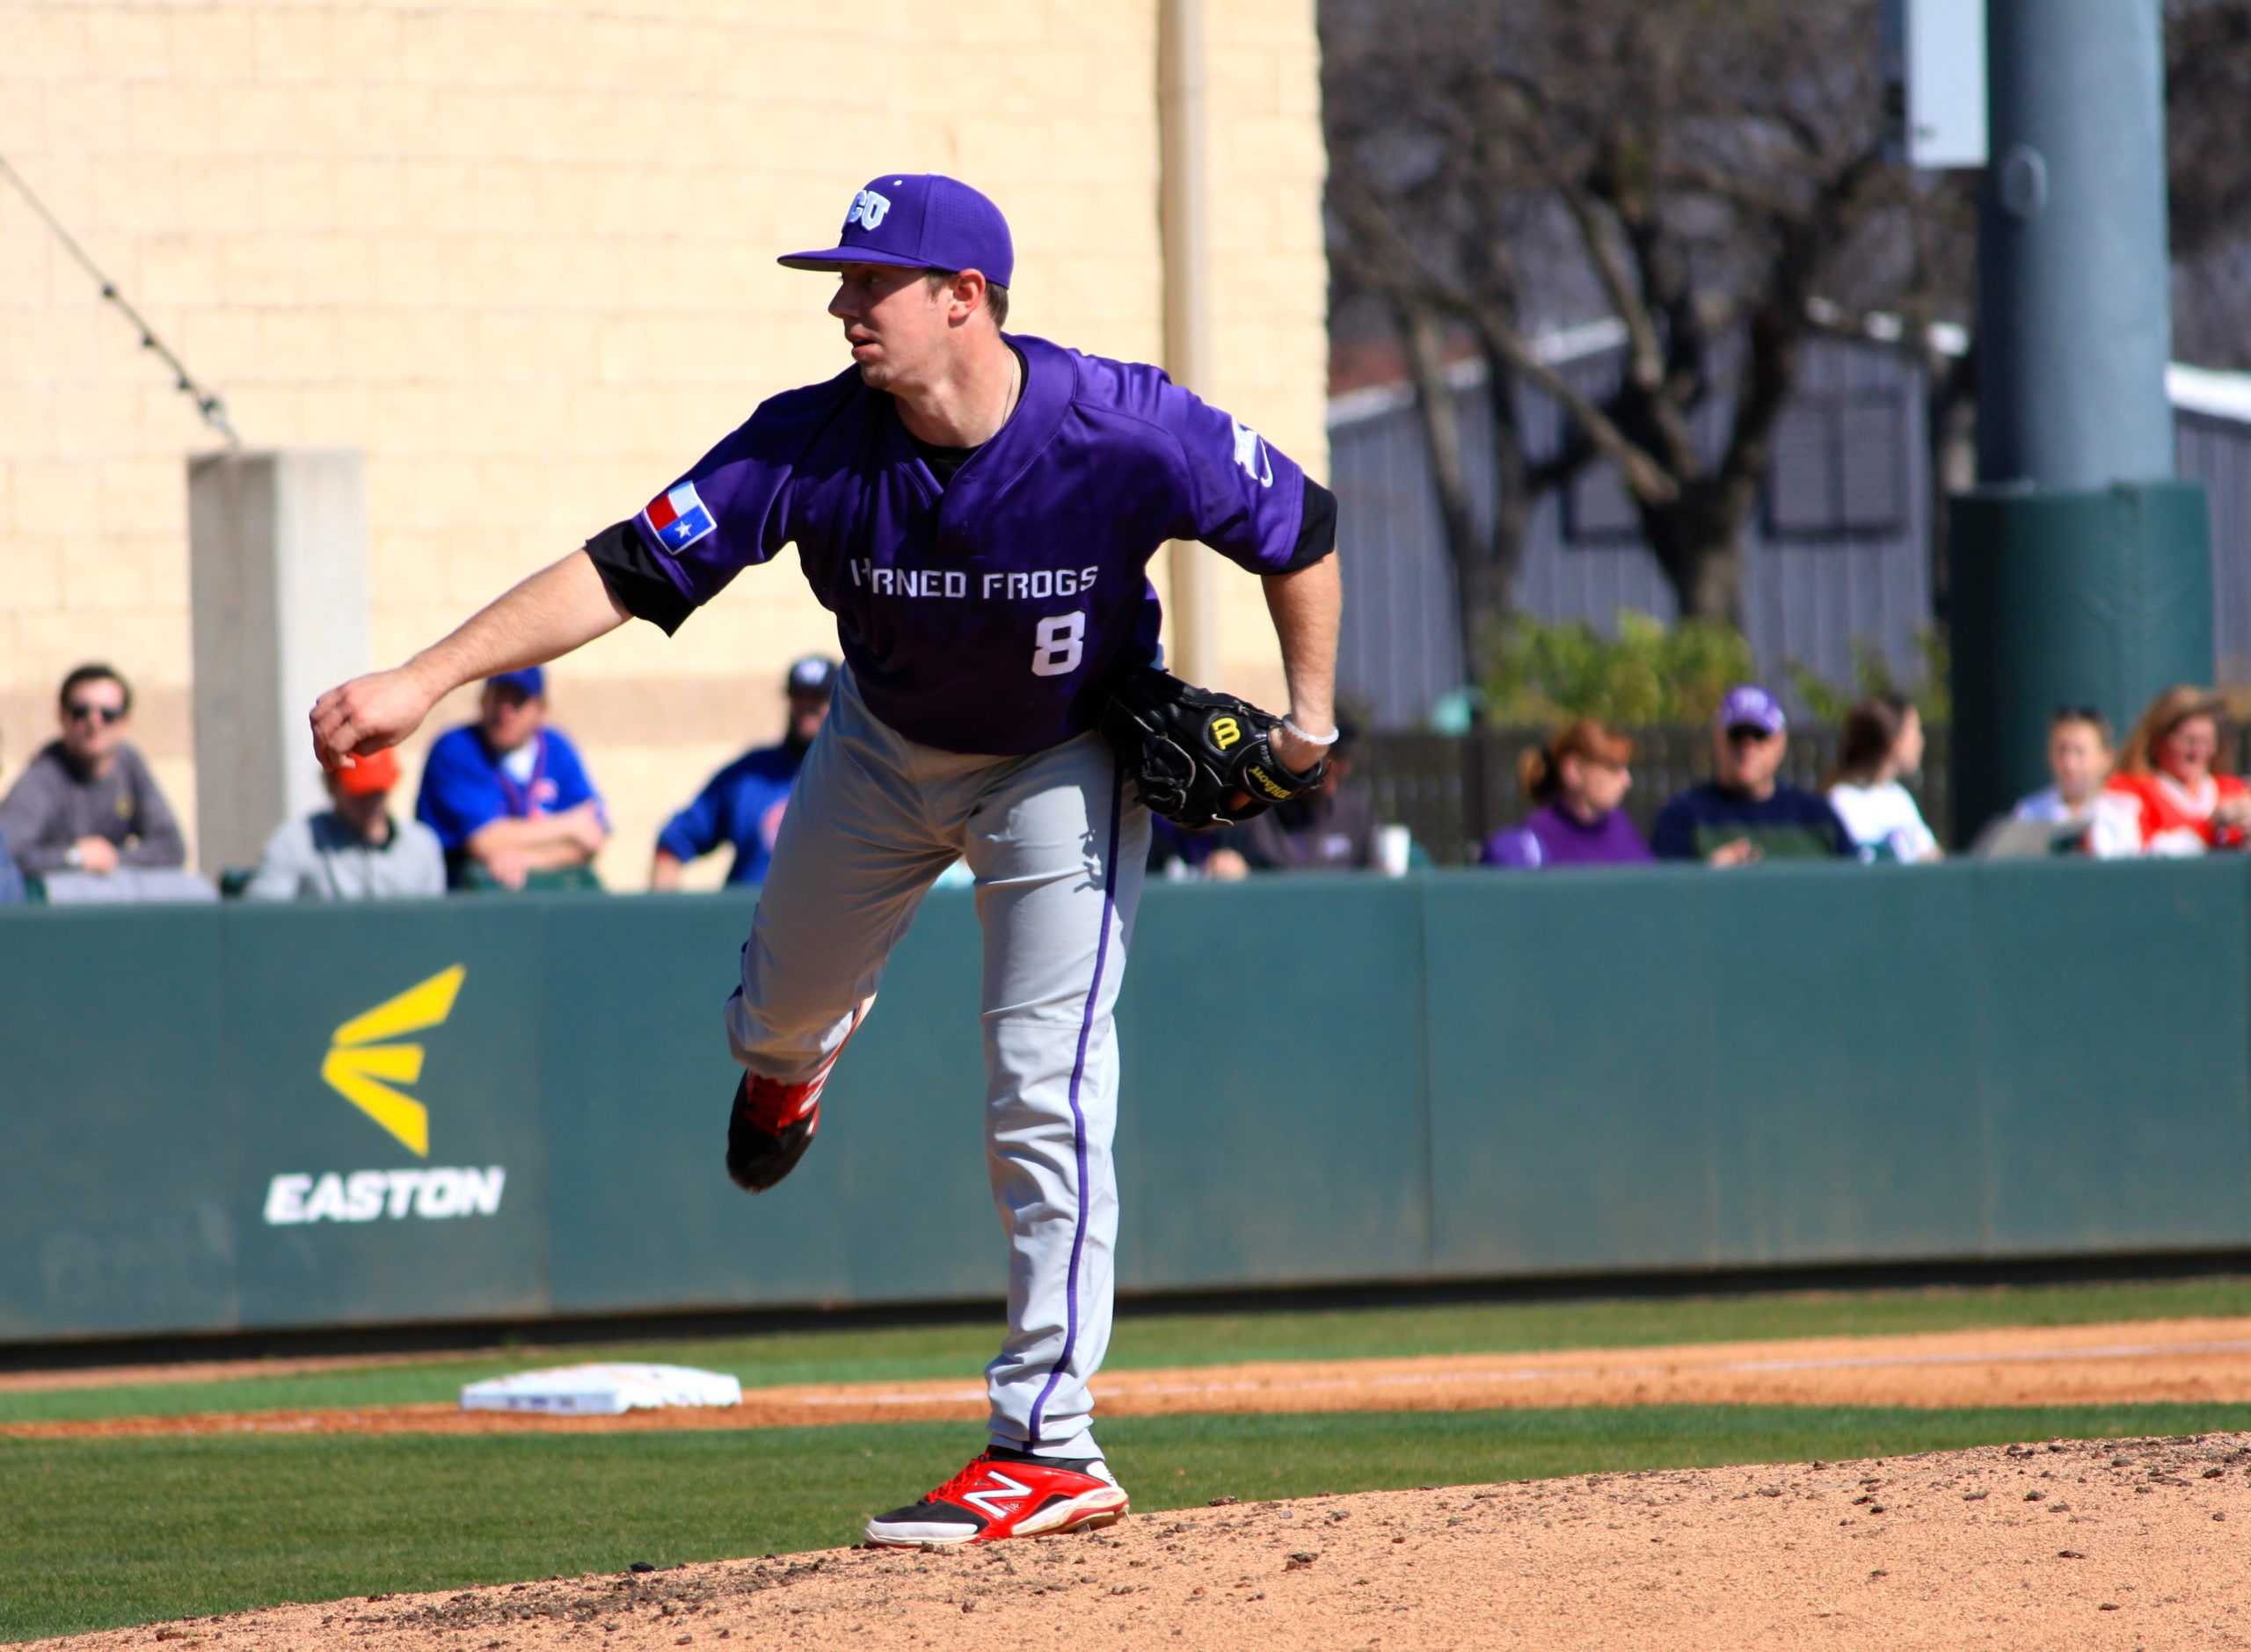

{"left": 0, "top": 664, "right": 186, "bottom": 877}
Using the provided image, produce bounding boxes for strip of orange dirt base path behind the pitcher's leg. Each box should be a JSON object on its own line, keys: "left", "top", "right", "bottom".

{"left": 13, "top": 1319, "right": 2251, "bottom": 1438}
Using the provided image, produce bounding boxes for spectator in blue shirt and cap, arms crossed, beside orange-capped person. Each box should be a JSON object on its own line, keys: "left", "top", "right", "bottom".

{"left": 414, "top": 666, "right": 610, "bottom": 889}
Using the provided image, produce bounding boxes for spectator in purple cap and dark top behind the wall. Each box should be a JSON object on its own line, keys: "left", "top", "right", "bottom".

{"left": 1650, "top": 682, "right": 1854, "bottom": 867}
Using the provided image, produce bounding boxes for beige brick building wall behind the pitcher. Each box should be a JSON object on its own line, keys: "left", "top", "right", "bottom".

{"left": 0, "top": 0, "right": 1328, "bottom": 889}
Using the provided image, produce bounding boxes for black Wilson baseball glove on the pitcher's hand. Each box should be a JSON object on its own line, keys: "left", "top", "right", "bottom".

{"left": 1103, "top": 666, "right": 1328, "bottom": 828}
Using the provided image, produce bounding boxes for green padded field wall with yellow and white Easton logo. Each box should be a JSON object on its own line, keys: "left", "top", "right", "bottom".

{"left": 0, "top": 860, "right": 2251, "bottom": 1342}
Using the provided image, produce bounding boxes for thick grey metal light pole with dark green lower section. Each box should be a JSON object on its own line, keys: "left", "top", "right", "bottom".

{"left": 1949, "top": 0, "right": 2212, "bottom": 837}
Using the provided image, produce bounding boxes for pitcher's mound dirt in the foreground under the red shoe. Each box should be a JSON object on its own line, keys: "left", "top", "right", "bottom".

{"left": 31, "top": 1434, "right": 2251, "bottom": 1652}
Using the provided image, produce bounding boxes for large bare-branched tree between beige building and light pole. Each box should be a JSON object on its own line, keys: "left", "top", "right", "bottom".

{"left": 1323, "top": 0, "right": 1913, "bottom": 639}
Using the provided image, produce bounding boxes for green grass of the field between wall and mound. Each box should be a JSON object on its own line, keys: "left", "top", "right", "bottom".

{"left": 0, "top": 1281, "right": 2251, "bottom": 1641}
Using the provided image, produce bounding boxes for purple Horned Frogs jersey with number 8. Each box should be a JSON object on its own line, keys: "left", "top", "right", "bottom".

{"left": 608, "top": 335, "right": 1335, "bottom": 756}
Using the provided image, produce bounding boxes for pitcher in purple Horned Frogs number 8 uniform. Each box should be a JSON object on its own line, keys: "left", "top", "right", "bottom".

{"left": 313, "top": 173, "right": 1339, "bottom": 1546}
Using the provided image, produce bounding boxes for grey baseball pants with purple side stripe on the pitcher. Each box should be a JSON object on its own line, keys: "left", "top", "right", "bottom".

{"left": 727, "top": 668, "right": 1148, "bottom": 1456}
